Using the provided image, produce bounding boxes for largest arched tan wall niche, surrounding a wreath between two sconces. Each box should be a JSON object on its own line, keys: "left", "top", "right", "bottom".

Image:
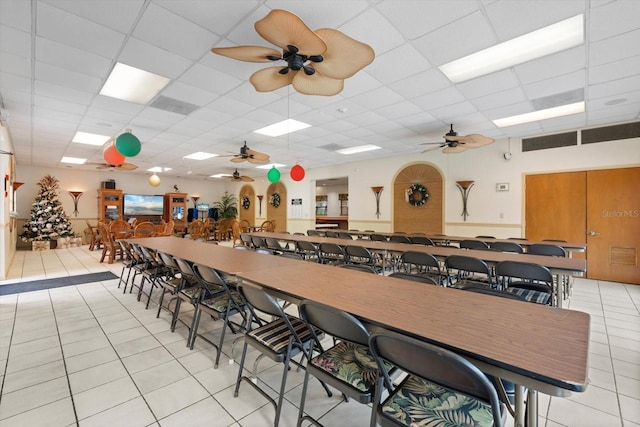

{"left": 393, "top": 163, "right": 444, "bottom": 234}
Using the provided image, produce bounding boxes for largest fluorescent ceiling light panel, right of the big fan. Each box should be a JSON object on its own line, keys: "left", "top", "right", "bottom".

{"left": 439, "top": 14, "right": 584, "bottom": 83}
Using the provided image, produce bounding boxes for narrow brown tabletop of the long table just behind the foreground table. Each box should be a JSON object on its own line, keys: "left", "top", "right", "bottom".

{"left": 249, "top": 232, "right": 587, "bottom": 274}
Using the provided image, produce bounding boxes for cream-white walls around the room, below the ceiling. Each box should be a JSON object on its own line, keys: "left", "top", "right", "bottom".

{"left": 5, "top": 134, "right": 640, "bottom": 280}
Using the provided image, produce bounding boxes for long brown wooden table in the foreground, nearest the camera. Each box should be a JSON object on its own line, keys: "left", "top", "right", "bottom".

{"left": 136, "top": 237, "right": 590, "bottom": 426}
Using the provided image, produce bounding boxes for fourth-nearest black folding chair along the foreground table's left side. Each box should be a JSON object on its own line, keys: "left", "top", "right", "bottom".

{"left": 189, "top": 264, "right": 248, "bottom": 369}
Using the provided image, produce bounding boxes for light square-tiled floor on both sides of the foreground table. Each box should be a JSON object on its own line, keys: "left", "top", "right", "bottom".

{"left": 0, "top": 246, "right": 640, "bottom": 427}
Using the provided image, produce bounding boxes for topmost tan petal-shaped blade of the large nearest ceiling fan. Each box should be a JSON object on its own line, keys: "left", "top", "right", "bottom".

{"left": 255, "top": 9, "right": 327, "bottom": 55}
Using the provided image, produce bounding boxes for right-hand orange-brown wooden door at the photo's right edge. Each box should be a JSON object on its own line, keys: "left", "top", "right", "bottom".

{"left": 586, "top": 168, "right": 640, "bottom": 284}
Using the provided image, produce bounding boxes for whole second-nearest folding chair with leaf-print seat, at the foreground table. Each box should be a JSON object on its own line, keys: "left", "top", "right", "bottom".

{"left": 298, "top": 300, "right": 382, "bottom": 426}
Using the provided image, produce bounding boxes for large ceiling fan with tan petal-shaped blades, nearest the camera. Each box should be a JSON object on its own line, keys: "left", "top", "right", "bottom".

{"left": 211, "top": 9, "right": 375, "bottom": 96}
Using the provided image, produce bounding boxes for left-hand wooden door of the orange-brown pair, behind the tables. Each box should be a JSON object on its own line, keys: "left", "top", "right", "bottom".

{"left": 525, "top": 172, "right": 587, "bottom": 251}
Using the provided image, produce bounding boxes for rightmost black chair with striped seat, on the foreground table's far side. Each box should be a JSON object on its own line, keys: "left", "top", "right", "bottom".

{"left": 496, "top": 261, "right": 558, "bottom": 305}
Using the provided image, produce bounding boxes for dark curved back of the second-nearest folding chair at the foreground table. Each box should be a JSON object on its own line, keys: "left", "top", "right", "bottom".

{"left": 299, "top": 300, "right": 370, "bottom": 346}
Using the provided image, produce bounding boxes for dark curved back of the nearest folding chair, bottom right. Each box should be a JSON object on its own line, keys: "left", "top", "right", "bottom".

{"left": 369, "top": 330, "right": 503, "bottom": 426}
